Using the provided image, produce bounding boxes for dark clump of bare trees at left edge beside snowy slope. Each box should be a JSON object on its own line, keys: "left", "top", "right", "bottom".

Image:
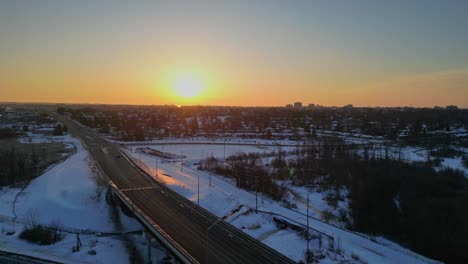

{"left": 0, "top": 147, "right": 46, "bottom": 186}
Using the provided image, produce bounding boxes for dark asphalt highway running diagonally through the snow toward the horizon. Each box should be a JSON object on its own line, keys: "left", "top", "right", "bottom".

{"left": 56, "top": 116, "right": 294, "bottom": 263}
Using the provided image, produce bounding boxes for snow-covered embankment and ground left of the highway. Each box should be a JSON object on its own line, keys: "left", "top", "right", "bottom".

{"left": 0, "top": 135, "right": 164, "bottom": 264}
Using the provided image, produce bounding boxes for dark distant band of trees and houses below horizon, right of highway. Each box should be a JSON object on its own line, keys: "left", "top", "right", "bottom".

{"left": 58, "top": 106, "right": 468, "bottom": 146}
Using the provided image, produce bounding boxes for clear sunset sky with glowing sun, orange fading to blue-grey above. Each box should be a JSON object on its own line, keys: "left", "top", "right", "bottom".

{"left": 0, "top": 0, "right": 468, "bottom": 107}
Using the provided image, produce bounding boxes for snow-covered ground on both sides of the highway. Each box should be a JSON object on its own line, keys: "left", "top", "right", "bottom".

{"left": 0, "top": 127, "right": 466, "bottom": 263}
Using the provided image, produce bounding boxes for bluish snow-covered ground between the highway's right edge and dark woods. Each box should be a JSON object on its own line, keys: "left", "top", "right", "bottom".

{"left": 124, "top": 144, "right": 434, "bottom": 263}
